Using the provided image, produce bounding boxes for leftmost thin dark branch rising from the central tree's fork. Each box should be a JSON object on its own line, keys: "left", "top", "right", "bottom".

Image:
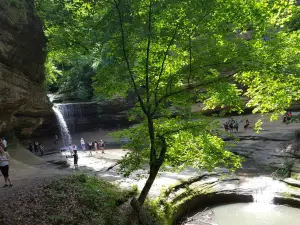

{"left": 114, "top": 0, "right": 148, "bottom": 115}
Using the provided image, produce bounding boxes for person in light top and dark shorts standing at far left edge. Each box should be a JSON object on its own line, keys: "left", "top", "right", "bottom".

{"left": 0, "top": 137, "right": 13, "bottom": 187}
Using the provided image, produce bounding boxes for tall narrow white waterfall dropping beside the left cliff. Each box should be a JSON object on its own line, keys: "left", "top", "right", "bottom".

{"left": 52, "top": 104, "right": 72, "bottom": 147}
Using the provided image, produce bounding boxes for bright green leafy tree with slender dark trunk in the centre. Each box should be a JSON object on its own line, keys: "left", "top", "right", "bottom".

{"left": 36, "top": 0, "right": 300, "bottom": 206}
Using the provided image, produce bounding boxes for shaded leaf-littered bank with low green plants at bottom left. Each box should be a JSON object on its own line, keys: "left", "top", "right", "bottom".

{"left": 0, "top": 175, "right": 135, "bottom": 225}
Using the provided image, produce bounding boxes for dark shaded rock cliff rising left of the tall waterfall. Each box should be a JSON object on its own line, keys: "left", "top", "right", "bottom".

{"left": 0, "top": 0, "right": 52, "bottom": 136}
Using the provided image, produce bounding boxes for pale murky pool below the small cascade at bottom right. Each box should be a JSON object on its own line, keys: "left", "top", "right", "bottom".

{"left": 183, "top": 203, "right": 300, "bottom": 225}
